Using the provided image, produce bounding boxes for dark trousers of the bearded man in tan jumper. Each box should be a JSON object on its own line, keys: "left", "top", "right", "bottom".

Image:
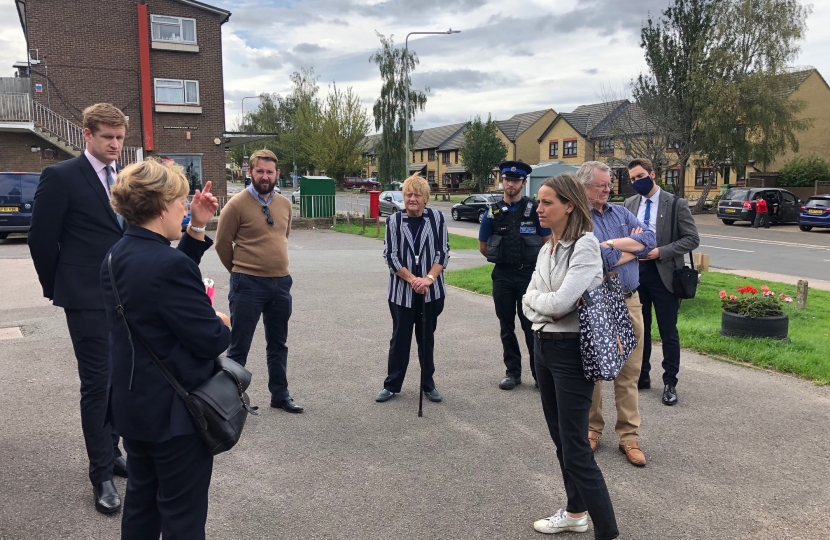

{"left": 228, "top": 272, "right": 293, "bottom": 401}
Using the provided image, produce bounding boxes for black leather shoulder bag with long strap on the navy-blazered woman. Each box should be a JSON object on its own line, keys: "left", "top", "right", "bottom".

{"left": 107, "top": 253, "right": 257, "bottom": 456}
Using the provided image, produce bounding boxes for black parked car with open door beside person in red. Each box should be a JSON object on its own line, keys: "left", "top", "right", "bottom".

{"left": 718, "top": 187, "right": 801, "bottom": 225}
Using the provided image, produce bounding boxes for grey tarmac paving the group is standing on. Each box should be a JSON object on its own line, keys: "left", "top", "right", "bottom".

{"left": 0, "top": 231, "right": 830, "bottom": 540}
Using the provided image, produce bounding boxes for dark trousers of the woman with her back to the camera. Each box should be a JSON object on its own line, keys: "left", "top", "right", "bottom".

{"left": 121, "top": 435, "right": 213, "bottom": 540}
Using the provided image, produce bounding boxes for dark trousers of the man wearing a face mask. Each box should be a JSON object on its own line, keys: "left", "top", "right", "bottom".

{"left": 637, "top": 261, "right": 680, "bottom": 386}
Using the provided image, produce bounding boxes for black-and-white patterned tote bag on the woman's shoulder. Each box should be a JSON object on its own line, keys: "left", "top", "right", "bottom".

{"left": 568, "top": 242, "right": 637, "bottom": 382}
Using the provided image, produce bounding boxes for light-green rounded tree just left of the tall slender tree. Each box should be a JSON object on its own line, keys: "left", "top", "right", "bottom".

{"left": 311, "top": 85, "right": 369, "bottom": 183}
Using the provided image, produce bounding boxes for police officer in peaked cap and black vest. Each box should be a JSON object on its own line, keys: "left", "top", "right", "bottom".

{"left": 478, "top": 161, "right": 551, "bottom": 390}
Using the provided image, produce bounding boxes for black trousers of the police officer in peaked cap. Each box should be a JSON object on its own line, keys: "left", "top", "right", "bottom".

{"left": 491, "top": 264, "right": 536, "bottom": 379}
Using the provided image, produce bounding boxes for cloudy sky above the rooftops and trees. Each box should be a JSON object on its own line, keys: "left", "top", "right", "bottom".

{"left": 0, "top": 0, "right": 830, "bottom": 131}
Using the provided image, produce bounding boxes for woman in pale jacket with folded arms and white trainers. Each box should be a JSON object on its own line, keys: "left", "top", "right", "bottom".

{"left": 522, "top": 174, "right": 619, "bottom": 540}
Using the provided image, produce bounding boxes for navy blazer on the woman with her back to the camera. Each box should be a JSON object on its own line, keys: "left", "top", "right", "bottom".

{"left": 99, "top": 227, "right": 231, "bottom": 442}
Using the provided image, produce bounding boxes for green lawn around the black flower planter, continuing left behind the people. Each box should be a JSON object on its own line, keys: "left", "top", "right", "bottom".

{"left": 445, "top": 265, "right": 830, "bottom": 384}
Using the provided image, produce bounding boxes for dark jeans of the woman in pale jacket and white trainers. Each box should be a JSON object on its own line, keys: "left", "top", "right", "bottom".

{"left": 535, "top": 339, "right": 619, "bottom": 540}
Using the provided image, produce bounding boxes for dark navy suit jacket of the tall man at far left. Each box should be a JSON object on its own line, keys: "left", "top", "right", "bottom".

{"left": 28, "top": 154, "right": 123, "bottom": 309}
